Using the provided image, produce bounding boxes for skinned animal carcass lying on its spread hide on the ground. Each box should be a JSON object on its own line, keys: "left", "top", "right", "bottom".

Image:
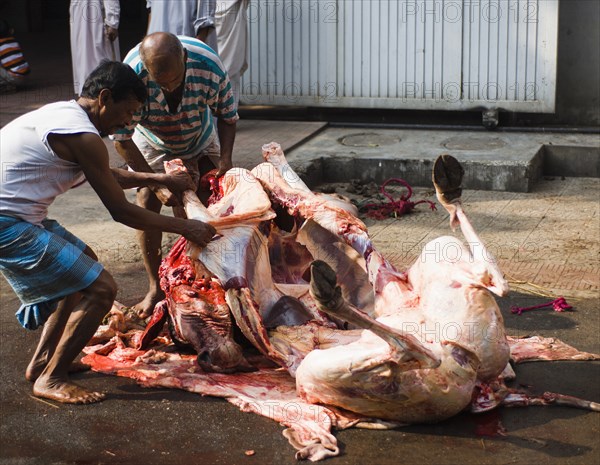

{"left": 84, "top": 143, "right": 599, "bottom": 461}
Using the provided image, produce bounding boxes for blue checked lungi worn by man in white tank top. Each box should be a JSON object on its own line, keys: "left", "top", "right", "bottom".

{"left": 0, "top": 215, "right": 104, "bottom": 329}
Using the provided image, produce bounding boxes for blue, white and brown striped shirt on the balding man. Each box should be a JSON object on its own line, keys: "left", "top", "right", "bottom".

{"left": 113, "top": 36, "right": 239, "bottom": 159}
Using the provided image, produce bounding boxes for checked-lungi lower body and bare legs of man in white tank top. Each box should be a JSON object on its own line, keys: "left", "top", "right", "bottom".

{"left": 0, "top": 215, "right": 112, "bottom": 403}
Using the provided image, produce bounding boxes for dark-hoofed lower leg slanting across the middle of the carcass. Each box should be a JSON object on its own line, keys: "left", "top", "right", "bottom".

{"left": 310, "top": 260, "right": 440, "bottom": 368}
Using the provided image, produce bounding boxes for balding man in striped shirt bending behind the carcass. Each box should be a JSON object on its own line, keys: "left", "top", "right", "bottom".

{"left": 113, "top": 32, "right": 238, "bottom": 317}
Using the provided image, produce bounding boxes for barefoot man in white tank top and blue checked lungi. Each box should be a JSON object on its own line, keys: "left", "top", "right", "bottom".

{"left": 0, "top": 62, "right": 215, "bottom": 404}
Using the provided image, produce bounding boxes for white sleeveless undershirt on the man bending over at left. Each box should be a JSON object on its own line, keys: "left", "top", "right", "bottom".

{"left": 0, "top": 100, "right": 100, "bottom": 225}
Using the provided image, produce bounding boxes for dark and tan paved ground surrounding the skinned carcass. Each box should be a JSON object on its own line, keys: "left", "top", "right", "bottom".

{"left": 0, "top": 156, "right": 600, "bottom": 465}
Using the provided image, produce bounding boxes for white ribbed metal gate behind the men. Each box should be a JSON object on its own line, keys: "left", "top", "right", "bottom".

{"left": 242, "top": 0, "right": 558, "bottom": 113}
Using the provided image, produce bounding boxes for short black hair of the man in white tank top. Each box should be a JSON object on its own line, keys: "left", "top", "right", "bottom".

{"left": 81, "top": 60, "right": 147, "bottom": 103}
